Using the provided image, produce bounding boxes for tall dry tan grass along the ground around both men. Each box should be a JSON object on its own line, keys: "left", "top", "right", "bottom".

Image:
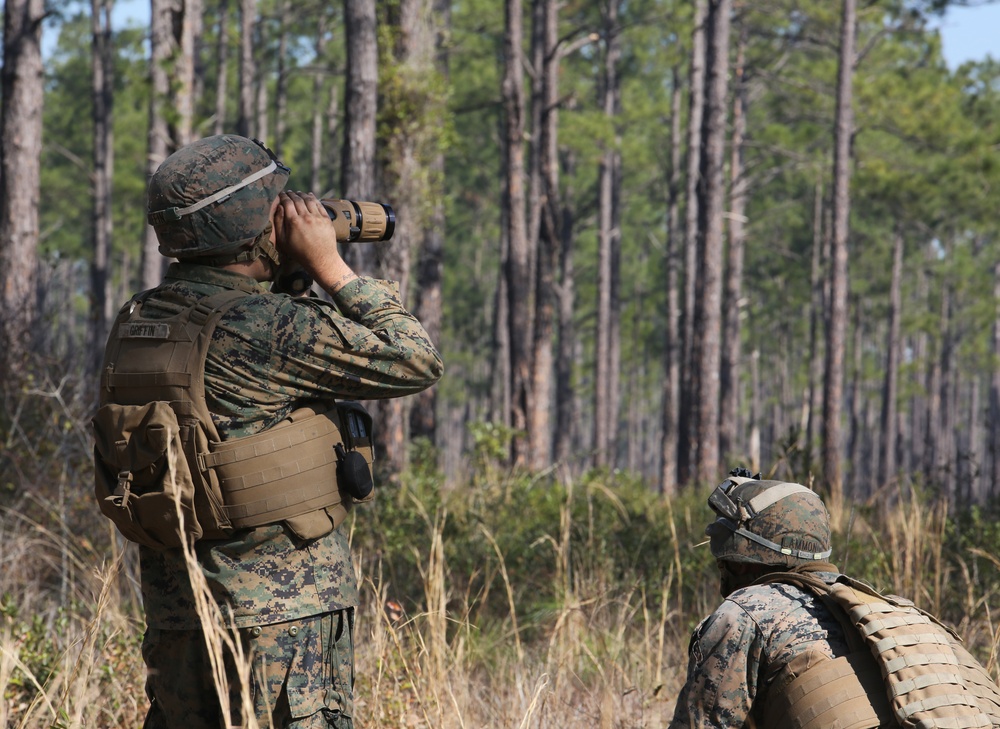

{"left": 0, "top": 472, "right": 1000, "bottom": 729}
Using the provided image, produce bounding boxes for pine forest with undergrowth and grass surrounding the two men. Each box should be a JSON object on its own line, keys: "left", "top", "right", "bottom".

{"left": 0, "top": 0, "right": 1000, "bottom": 726}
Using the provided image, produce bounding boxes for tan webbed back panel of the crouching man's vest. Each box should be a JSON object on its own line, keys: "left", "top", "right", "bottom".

{"left": 756, "top": 574, "right": 1000, "bottom": 729}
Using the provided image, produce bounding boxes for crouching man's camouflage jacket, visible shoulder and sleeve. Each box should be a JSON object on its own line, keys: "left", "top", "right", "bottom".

{"left": 670, "top": 572, "right": 850, "bottom": 729}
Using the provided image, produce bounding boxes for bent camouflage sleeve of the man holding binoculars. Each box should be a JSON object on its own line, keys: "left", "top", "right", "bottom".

{"left": 272, "top": 278, "right": 444, "bottom": 399}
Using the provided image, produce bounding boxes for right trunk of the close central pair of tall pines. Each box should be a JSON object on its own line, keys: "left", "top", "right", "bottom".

{"left": 528, "top": 0, "right": 563, "bottom": 470}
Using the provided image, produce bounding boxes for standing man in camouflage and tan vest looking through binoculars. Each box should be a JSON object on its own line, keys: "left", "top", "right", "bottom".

{"left": 94, "top": 135, "right": 442, "bottom": 729}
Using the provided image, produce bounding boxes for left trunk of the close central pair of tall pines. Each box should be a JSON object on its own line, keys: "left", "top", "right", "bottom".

{"left": 502, "top": 0, "right": 532, "bottom": 465}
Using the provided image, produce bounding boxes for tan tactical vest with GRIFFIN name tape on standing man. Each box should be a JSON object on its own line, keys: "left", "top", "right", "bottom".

{"left": 93, "top": 290, "right": 374, "bottom": 549}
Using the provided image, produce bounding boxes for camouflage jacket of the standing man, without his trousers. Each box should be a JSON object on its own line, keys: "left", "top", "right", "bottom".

{"left": 132, "top": 263, "right": 443, "bottom": 629}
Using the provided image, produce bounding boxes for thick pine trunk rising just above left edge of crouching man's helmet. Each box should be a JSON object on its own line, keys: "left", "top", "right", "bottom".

{"left": 694, "top": 0, "right": 732, "bottom": 481}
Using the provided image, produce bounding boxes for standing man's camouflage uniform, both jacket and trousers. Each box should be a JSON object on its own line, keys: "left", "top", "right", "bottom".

{"left": 132, "top": 263, "right": 442, "bottom": 729}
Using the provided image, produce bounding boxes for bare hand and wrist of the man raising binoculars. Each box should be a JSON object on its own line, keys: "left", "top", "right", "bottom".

{"left": 274, "top": 191, "right": 357, "bottom": 294}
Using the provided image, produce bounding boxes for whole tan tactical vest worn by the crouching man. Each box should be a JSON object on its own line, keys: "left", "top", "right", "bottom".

{"left": 758, "top": 573, "right": 1000, "bottom": 729}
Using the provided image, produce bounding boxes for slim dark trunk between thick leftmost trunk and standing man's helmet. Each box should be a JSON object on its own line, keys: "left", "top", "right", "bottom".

{"left": 87, "top": 0, "right": 115, "bottom": 376}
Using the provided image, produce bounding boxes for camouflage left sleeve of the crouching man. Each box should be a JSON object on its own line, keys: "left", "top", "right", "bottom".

{"left": 670, "top": 601, "right": 762, "bottom": 729}
